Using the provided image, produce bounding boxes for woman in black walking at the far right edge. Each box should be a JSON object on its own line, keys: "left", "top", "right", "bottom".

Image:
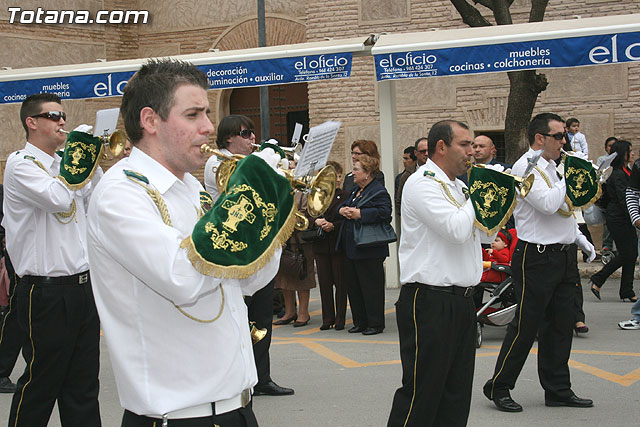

{"left": 591, "top": 140, "right": 638, "bottom": 301}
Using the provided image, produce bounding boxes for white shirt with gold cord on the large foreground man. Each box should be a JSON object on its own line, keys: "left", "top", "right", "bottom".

{"left": 88, "top": 147, "right": 279, "bottom": 416}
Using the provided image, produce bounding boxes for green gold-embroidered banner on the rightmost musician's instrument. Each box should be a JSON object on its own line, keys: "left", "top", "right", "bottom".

{"left": 564, "top": 156, "right": 602, "bottom": 208}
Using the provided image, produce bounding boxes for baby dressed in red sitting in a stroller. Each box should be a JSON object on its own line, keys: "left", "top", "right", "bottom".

{"left": 474, "top": 229, "right": 518, "bottom": 348}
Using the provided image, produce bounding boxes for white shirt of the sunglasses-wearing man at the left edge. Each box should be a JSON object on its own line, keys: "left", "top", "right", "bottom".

{"left": 2, "top": 142, "right": 102, "bottom": 277}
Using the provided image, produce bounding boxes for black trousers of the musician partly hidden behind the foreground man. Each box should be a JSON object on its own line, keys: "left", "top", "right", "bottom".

{"left": 244, "top": 279, "right": 275, "bottom": 385}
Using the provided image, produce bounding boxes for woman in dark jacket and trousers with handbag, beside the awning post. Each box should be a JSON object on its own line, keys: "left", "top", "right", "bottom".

{"left": 338, "top": 154, "right": 391, "bottom": 335}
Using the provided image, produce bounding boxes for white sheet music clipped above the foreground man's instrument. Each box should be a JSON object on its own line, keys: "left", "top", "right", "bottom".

{"left": 293, "top": 121, "right": 342, "bottom": 178}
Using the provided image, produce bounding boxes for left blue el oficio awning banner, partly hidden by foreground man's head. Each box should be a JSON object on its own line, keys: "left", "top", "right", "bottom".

{"left": 0, "top": 52, "right": 352, "bottom": 104}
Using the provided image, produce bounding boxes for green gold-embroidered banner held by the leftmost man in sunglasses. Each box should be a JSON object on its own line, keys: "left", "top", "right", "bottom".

{"left": 59, "top": 131, "right": 103, "bottom": 190}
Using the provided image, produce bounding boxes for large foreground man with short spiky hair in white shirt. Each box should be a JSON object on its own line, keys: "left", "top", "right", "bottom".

{"left": 88, "top": 60, "right": 284, "bottom": 427}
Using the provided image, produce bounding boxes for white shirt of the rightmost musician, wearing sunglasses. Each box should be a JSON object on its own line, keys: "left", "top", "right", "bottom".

{"left": 512, "top": 148, "right": 582, "bottom": 245}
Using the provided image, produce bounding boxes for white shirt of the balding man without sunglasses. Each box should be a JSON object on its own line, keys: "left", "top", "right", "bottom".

{"left": 398, "top": 159, "right": 487, "bottom": 286}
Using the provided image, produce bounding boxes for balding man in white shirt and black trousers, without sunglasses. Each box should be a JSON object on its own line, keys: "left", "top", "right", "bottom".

{"left": 388, "top": 120, "right": 486, "bottom": 427}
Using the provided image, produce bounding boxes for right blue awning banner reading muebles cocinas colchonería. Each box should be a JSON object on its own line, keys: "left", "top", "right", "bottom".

{"left": 374, "top": 32, "right": 640, "bottom": 81}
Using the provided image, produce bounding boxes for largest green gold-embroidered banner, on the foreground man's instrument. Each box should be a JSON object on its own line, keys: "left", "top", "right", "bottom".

{"left": 182, "top": 155, "right": 295, "bottom": 278}
